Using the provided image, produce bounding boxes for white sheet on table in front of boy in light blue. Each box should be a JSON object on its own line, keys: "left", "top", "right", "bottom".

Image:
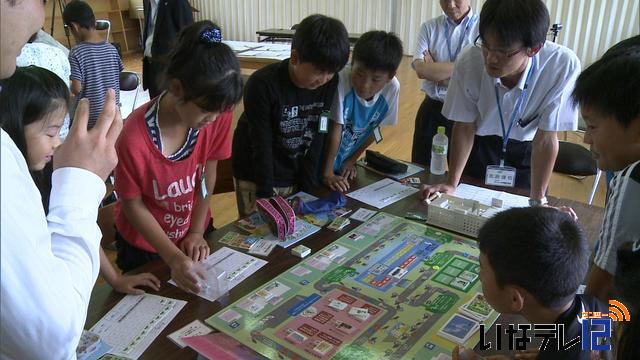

{"left": 347, "top": 178, "right": 418, "bottom": 209}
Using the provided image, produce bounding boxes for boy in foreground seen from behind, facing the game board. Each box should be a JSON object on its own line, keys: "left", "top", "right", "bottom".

{"left": 452, "top": 207, "right": 609, "bottom": 359}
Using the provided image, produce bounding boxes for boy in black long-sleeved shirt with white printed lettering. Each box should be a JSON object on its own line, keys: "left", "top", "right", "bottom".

{"left": 232, "top": 15, "right": 349, "bottom": 217}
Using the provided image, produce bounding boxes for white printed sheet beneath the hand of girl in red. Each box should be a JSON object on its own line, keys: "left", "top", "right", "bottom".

{"left": 169, "top": 247, "right": 267, "bottom": 301}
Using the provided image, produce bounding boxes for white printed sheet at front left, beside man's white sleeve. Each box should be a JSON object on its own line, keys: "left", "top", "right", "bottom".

{"left": 90, "top": 294, "right": 187, "bottom": 359}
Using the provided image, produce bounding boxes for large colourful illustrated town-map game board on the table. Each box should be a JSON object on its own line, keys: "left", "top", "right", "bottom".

{"left": 207, "top": 213, "right": 498, "bottom": 360}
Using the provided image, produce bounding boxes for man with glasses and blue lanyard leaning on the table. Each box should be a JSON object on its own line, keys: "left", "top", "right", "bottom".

{"left": 423, "top": 0, "right": 580, "bottom": 205}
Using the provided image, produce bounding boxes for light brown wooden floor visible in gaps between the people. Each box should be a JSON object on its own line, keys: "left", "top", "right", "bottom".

{"left": 99, "top": 55, "right": 606, "bottom": 284}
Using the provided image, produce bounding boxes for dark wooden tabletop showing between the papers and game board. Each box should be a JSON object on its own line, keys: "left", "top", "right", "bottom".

{"left": 85, "top": 167, "right": 603, "bottom": 359}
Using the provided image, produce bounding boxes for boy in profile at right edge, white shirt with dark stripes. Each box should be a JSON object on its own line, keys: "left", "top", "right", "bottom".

{"left": 573, "top": 36, "right": 640, "bottom": 301}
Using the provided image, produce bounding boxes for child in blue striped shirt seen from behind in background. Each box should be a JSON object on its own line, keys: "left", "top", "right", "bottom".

{"left": 62, "top": 0, "right": 124, "bottom": 128}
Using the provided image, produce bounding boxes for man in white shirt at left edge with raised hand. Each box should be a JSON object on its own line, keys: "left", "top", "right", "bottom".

{"left": 0, "top": 0, "right": 122, "bottom": 359}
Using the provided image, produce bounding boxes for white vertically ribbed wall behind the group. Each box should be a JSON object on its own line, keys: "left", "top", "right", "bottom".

{"left": 191, "top": 0, "right": 640, "bottom": 66}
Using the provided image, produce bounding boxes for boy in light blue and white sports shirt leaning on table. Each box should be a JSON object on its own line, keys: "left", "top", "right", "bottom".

{"left": 323, "top": 31, "right": 402, "bottom": 191}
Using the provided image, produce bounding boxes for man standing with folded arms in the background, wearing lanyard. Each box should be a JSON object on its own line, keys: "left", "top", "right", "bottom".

{"left": 411, "top": 0, "right": 478, "bottom": 165}
